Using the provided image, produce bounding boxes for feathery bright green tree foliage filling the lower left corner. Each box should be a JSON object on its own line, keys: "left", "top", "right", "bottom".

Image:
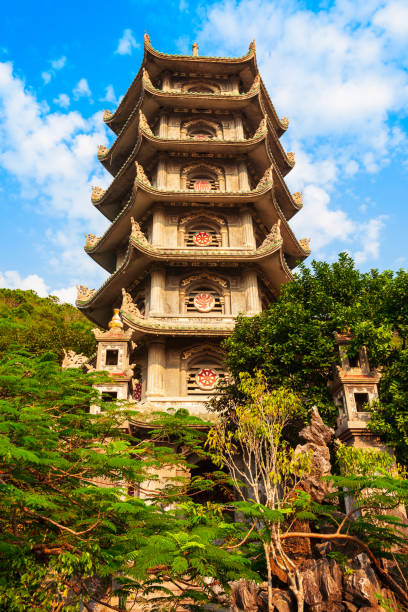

{"left": 0, "top": 352, "right": 256, "bottom": 612}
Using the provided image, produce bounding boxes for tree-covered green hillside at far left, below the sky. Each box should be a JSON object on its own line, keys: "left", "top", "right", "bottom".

{"left": 0, "top": 289, "right": 95, "bottom": 360}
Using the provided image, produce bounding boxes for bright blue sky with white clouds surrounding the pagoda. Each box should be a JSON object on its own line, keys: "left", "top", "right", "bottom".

{"left": 0, "top": 0, "right": 408, "bottom": 301}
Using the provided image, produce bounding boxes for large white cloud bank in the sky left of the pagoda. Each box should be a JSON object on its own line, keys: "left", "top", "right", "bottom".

{"left": 0, "top": 62, "right": 111, "bottom": 286}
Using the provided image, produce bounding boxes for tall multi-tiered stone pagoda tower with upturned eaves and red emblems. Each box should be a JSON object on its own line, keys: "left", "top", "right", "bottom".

{"left": 77, "top": 35, "right": 309, "bottom": 414}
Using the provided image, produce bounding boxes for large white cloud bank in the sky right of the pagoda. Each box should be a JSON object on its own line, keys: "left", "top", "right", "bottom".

{"left": 198, "top": 0, "right": 408, "bottom": 262}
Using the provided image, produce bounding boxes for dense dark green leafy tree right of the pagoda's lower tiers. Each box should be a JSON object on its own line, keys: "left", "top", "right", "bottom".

{"left": 225, "top": 253, "right": 408, "bottom": 464}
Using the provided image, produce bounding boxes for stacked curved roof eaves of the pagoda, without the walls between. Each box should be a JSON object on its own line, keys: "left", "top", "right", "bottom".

{"left": 77, "top": 35, "right": 310, "bottom": 335}
